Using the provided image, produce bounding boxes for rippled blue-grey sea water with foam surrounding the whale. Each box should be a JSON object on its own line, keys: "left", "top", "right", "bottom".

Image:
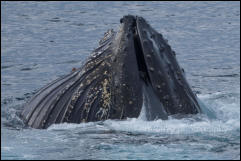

{"left": 1, "top": 1, "right": 240, "bottom": 159}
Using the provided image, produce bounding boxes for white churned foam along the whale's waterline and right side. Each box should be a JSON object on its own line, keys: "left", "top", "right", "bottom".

{"left": 45, "top": 93, "right": 240, "bottom": 135}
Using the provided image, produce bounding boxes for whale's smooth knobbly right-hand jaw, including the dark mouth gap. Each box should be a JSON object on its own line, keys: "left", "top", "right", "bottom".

{"left": 121, "top": 16, "right": 201, "bottom": 120}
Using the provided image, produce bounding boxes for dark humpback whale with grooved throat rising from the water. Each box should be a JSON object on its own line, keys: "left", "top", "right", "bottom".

{"left": 21, "top": 15, "right": 202, "bottom": 129}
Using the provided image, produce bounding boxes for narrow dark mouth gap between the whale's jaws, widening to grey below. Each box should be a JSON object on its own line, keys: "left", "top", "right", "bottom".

{"left": 122, "top": 17, "right": 168, "bottom": 120}
